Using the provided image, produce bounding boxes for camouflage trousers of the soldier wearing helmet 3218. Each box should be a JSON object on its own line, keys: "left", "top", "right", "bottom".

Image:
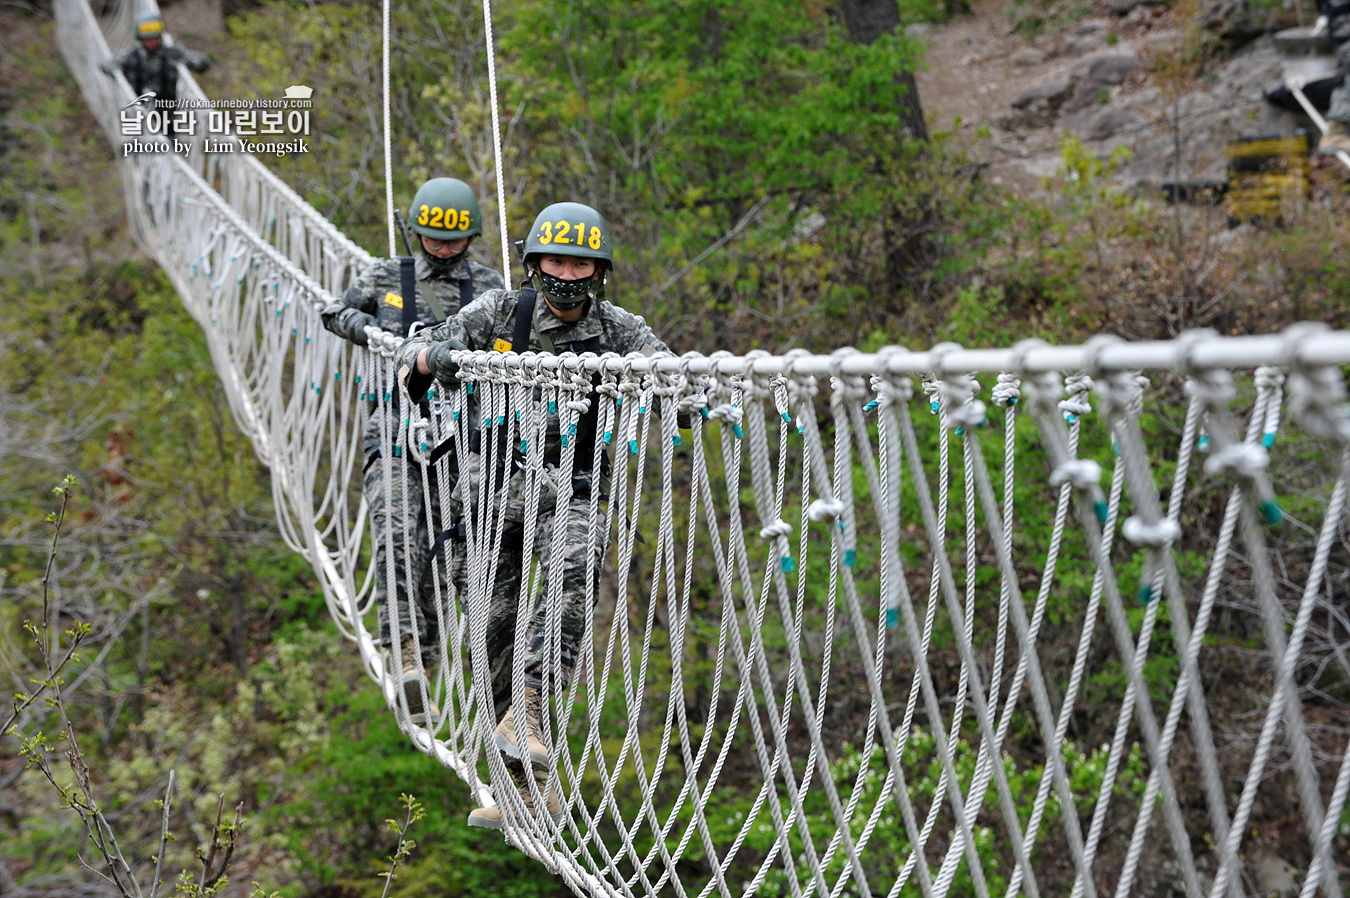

{"left": 451, "top": 451, "right": 608, "bottom": 720}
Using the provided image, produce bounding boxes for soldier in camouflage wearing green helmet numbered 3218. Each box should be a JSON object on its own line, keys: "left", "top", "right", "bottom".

{"left": 398, "top": 203, "right": 666, "bottom": 829}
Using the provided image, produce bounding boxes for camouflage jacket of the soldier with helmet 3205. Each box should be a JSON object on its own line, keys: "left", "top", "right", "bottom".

{"left": 320, "top": 253, "right": 505, "bottom": 346}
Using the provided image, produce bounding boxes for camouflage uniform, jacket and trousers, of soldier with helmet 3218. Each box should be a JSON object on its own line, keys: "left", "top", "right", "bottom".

{"left": 397, "top": 290, "right": 666, "bottom": 720}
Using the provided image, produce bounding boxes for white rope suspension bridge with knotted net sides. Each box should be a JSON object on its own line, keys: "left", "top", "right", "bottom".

{"left": 57, "top": 0, "right": 1350, "bottom": 898}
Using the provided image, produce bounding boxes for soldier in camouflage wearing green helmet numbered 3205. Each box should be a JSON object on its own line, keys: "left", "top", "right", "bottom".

{"left": 321, "top": 178, "right": 505, "bottom": 724}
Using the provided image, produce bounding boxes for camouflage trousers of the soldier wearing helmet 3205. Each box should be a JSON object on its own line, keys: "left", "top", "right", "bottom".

{"left": 365, "top": 432, "right": 455, "bottom": 670}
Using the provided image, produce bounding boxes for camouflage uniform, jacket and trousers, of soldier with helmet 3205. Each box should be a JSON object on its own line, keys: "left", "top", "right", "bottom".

{"left": 320, "top": 254, "right": 504, "bottom": 668}
